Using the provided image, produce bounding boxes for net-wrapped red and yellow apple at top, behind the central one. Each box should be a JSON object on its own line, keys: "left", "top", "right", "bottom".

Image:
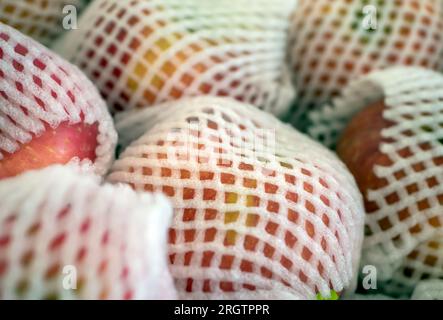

{"left": 55, "top": 0, "right": 296, "bottom": 115}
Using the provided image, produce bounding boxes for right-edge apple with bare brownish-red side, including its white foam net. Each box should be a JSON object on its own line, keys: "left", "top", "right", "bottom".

{"left": 328, "top": 67, "right": 443, "bottom": 297}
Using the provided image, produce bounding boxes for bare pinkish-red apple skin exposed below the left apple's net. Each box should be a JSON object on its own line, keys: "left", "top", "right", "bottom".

{"left": 0, "top": 122, "right": 98, "bottom": 179}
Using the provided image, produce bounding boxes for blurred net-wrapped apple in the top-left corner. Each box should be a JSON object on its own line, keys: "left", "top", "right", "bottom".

{"left": 0, "top": 0, "right": 89, "bottom": 45}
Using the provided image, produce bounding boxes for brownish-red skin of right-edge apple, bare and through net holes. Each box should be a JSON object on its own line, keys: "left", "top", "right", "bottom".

{"left": 337, "top": 101, "right": 443, "bottom": 237}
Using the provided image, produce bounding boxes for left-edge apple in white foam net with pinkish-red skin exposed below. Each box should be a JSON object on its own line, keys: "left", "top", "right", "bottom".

{"left": 0, "top": 23, "right": 117, "bottom": 179}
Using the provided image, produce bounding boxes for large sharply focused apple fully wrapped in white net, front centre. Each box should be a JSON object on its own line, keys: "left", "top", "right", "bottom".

{"left": 108, "top": 97, "right": 364, "bottom": 299}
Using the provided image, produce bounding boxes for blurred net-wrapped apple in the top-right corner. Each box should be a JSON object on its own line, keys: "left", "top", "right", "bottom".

{"left": 289, "top": 0, "right": 443, "bottom": 130}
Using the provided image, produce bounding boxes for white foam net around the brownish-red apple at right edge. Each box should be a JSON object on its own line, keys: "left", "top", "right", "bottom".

{"left": 315, "top": 67, "right": 443, "bottom": 293}
